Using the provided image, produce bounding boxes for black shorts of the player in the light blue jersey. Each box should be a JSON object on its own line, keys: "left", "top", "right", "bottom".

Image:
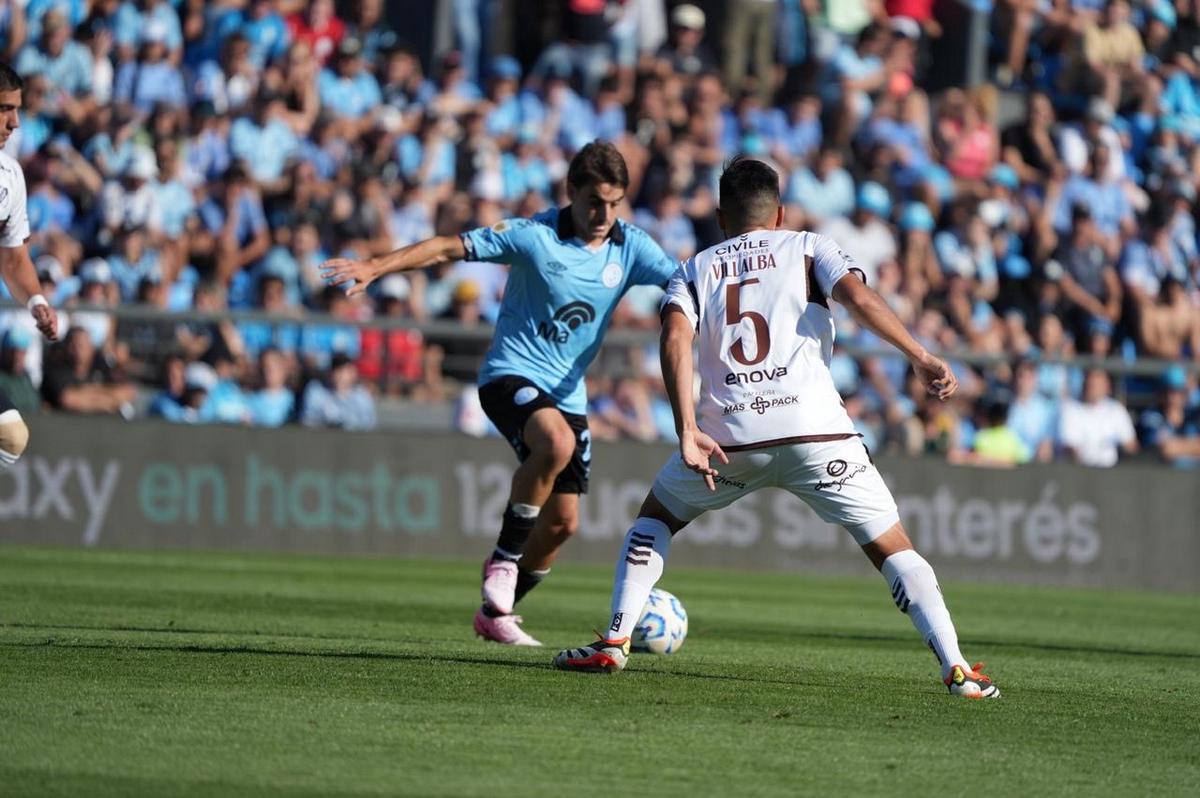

{"left": 479, "top": 377, "right": 592, "bottom": 493}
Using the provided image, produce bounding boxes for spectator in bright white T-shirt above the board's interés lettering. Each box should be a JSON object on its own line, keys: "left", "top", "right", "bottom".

{"left": 1058, "top": 368, "right": 1138, "bottom": 468}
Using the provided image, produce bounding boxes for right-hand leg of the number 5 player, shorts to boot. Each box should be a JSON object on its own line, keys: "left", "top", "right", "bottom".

{"left": 784, "top": 438, "right": 1000, "bottom": 698}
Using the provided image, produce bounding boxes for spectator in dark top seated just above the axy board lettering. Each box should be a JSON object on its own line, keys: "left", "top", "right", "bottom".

{"left": 42, "top": 326, "right": 137, "bottom": 418}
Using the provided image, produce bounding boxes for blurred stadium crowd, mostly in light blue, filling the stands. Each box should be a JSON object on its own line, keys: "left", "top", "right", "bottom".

{"left": 0, "top": 0, "right": 1200, "bottom": 466}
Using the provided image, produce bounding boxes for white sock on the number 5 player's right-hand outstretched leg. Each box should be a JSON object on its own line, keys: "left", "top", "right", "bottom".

{"left": 880, "top": 548, "right": 967, "bottom": 678}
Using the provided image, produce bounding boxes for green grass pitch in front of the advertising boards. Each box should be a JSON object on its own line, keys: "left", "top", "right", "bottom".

{"left": 0, "top": 547, "right": 1200, "bottom": 798}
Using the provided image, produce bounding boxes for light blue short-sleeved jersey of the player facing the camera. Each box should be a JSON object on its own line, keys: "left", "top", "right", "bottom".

{"left": 462, "top": 209, "right": 678, "bottom": 415}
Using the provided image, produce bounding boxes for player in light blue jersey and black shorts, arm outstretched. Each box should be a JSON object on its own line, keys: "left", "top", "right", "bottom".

{"left": 323, "top": 142, "right": 677, "bottom": 646}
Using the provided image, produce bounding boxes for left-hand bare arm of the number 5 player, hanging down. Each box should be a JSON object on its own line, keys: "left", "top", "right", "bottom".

{"left": 659, "top": 305, "right": 730, "bottom": 491}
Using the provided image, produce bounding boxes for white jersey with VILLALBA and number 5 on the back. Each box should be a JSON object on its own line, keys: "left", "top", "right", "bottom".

{"left": 662, "top": 230, "right": 860, "bottom": 451}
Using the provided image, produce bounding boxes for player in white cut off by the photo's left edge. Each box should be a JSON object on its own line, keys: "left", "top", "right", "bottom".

{"left": 0, "top": 64, "right": 58, "bottom": 468}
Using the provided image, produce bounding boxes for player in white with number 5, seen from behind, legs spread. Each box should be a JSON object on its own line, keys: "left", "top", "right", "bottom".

{"left": 554, "top": 158, "right": 1000, "bottom": 698}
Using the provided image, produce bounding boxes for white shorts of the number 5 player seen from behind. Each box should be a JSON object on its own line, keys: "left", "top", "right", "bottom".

{"left": 654, "top": 438, "right": 900, "bottom": 546}
